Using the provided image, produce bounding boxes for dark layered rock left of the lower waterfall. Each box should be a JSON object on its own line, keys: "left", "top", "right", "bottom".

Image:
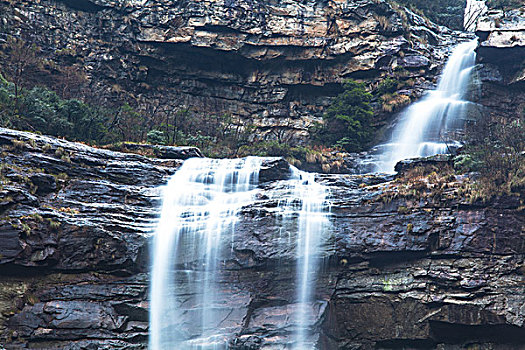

{"left": 0, "top": 129, "right": 182, "bottom": 349}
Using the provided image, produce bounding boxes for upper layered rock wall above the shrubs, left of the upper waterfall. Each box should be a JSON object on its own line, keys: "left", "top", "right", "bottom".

{"left": 0, "top": 0, "right": 458, "bottom": 143}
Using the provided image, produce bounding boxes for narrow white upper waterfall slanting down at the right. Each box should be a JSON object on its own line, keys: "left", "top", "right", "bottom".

{"left": 375, "top": 40, "right": 477, "bottom": 173}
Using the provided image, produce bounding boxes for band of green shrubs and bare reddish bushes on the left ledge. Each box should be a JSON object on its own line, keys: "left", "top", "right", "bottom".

{"left": 0, "top": 37, "right": 254, "bottom": 157}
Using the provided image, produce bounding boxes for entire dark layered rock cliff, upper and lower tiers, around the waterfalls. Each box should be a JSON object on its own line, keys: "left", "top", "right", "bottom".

{"left": 0, "top": 0, "right": 525, "bottom": 349}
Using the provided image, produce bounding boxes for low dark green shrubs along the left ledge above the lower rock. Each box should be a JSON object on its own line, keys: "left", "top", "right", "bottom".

{"left": 0, "top": 71, "right": 260, "bottom": 157}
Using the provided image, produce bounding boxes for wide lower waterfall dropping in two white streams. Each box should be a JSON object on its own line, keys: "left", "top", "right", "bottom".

{"left": 149, "top": 157, "right": 328, "bottom": 350}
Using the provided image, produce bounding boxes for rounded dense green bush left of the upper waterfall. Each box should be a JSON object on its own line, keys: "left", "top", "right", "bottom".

{"left": 316, "top": 80, "right": 374, "bottom": 152}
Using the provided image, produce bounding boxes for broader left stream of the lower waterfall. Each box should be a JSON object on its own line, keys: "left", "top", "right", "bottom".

{"left": 149, "top": 157, "right": 261, "bottom": 350}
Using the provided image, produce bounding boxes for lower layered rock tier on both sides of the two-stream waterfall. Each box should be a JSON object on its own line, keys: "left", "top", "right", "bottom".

{"left": 0, "top": 129, "right": 525, "bottom": 349}
